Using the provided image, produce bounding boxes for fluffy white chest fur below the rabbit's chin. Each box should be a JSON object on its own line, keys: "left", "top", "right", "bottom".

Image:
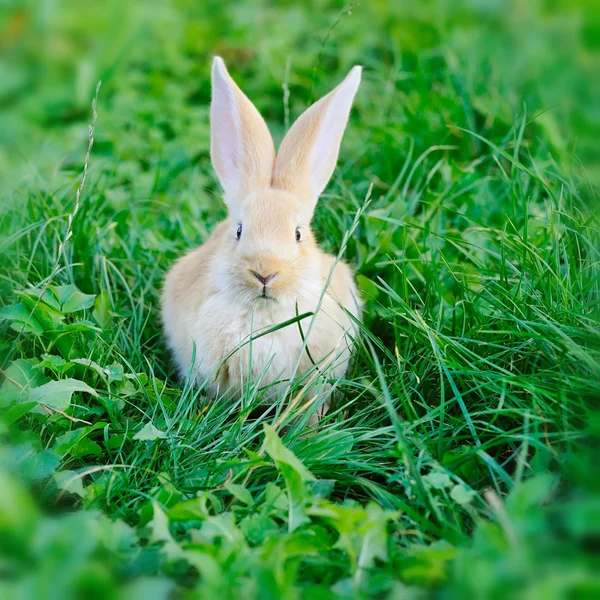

{"left": 189, "top": 294, "right": 349, "bottom": 394}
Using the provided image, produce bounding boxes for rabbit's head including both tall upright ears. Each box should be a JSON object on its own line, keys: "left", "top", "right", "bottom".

{"left": 210, "top": 57, "right": 361, "bottom": 306}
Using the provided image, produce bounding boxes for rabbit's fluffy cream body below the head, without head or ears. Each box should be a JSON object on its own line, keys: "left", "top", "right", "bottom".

{"left": 163, "top": 221, "right": 360, "bottom": 395}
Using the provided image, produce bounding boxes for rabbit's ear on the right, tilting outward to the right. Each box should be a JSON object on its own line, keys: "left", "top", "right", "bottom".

{"left": 273, "top": 66, "right": 361, "bottom": 211}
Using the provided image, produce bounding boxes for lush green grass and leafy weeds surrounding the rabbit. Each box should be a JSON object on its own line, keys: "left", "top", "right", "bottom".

{"left": 0, "top": 0, "right": 600, "bottom": 600}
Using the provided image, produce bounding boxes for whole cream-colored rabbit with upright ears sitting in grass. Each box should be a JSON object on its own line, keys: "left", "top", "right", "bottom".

{"left": 162, "top": 57, "right": 361, "bottom": 408}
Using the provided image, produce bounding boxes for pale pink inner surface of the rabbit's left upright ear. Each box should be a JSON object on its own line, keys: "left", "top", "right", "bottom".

{"left": 210, "top": 73, "right": 242, "bottom": 193}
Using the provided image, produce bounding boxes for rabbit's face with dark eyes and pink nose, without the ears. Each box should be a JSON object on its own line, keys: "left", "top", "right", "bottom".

{"left": 223, "top": 189, "right": 318, "bottom": 304}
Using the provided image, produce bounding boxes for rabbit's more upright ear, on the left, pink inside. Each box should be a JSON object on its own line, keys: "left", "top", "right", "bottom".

{"left": 210, "top": 56, "right": 275, "bottom": 209}
